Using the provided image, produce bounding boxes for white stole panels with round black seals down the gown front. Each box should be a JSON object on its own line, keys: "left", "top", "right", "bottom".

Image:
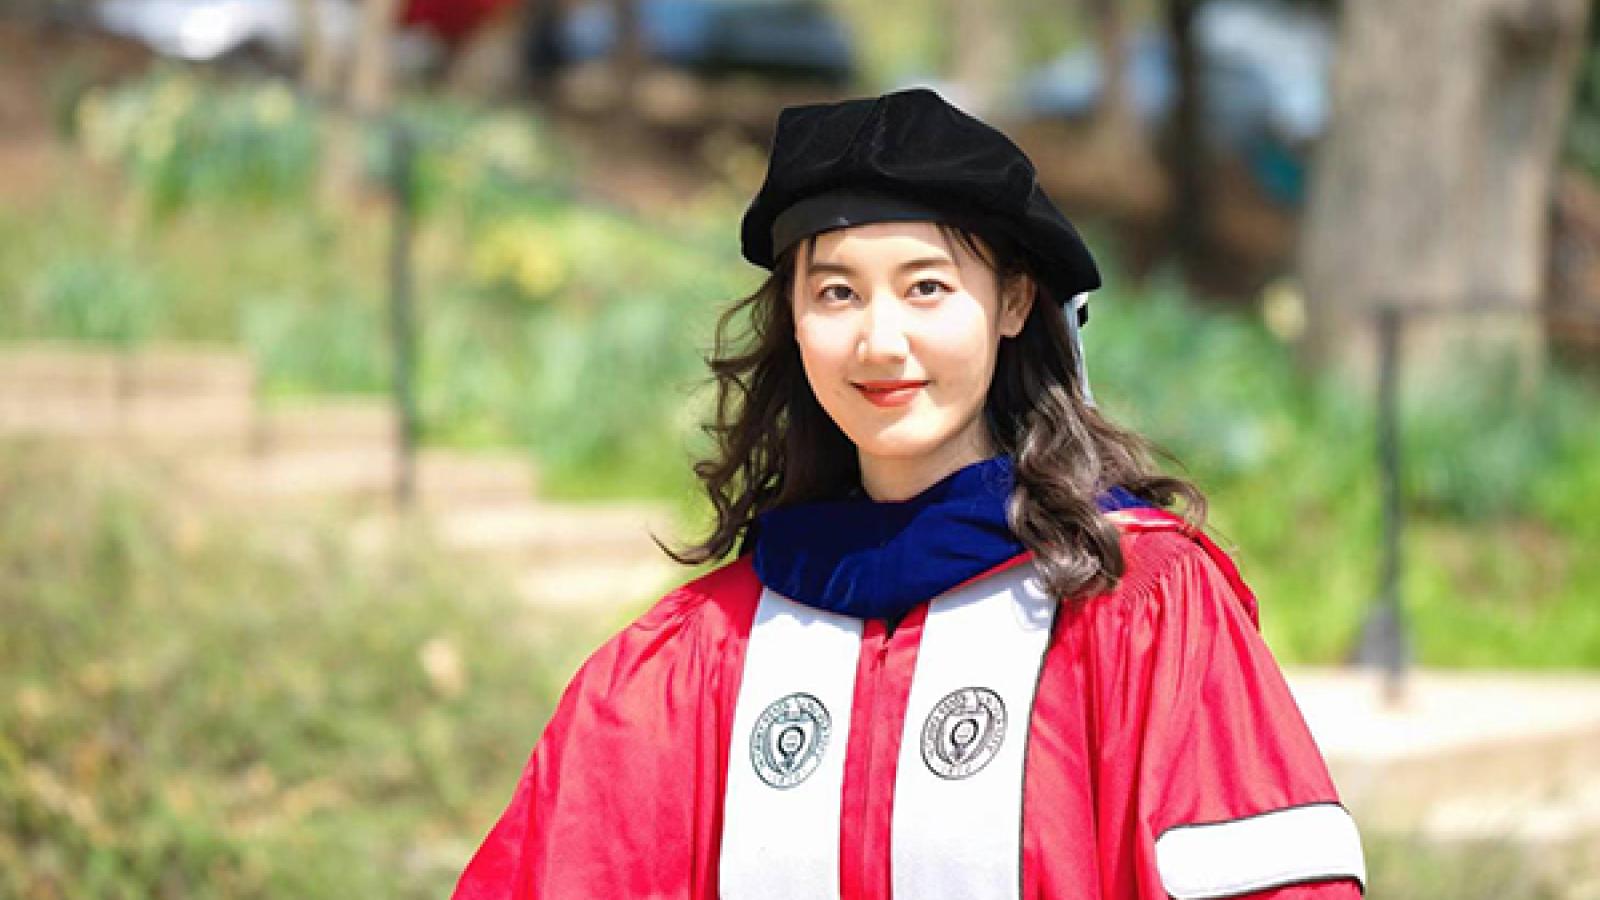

{"left": 720, "top": 564, "right": 1056, "bottom": 900}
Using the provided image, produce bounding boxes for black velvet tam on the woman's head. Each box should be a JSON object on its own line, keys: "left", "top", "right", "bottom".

{"left": 739, "top": 88, "right": 1101, "bottom": 303}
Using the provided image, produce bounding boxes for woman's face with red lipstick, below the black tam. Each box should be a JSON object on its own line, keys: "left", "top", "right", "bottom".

{"left": 794, "top": 223, "right": 1034, "bottom": 500}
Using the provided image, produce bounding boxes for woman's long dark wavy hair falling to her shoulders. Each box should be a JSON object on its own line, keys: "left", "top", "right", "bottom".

{"left": 662, "top": 223, "right": 1206, "bottom": 599}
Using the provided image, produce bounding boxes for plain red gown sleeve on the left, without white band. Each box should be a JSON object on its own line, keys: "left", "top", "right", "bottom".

{"left": 453, "top": 570, "right": 741, "bottom": 900}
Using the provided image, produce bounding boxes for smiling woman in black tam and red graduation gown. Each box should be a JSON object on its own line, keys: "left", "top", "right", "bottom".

{"left": 456, "top": 90, "right": 1365, "bottom": 900}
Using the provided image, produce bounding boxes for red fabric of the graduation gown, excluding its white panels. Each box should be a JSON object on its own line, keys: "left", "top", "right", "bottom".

{"left": 454, "top": 509, "right": 1360, "bottom": 900}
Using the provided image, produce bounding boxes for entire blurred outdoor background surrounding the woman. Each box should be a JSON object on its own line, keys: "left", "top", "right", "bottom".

{"left": 0, "top": 0, "right": 1600, "bottom": 900}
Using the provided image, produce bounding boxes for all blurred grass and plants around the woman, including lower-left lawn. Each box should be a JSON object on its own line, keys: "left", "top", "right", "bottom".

{"left": 0, "top": 70, "right": 1600, "bottom": 900}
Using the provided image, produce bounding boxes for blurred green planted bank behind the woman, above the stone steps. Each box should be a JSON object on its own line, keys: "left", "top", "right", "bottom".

{"left": 0, "top": 72, "right": 1600, "bottom": 668}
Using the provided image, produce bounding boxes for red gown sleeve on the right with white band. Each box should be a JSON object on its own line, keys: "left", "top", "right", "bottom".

{"left": 1090, "top": 532, "right": 1366, "bottom": 900}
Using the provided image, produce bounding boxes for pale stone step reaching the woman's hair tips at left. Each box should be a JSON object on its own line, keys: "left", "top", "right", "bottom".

{"left": 438, "top": 503, "right": 672, "bottom": 564}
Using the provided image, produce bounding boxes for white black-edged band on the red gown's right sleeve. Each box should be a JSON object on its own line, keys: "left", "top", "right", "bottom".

{"left": 1155, "top": 802, "right": 1366, "bottom": 900}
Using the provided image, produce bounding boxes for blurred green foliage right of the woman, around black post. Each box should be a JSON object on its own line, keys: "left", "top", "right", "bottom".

{"left": 1085, "top": 285, "right": 1600, "bottom": 668}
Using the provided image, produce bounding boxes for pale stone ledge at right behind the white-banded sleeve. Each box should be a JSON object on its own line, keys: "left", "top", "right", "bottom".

{"left": 1290, "top": 669, "right": 1600, "bottom": 833}
